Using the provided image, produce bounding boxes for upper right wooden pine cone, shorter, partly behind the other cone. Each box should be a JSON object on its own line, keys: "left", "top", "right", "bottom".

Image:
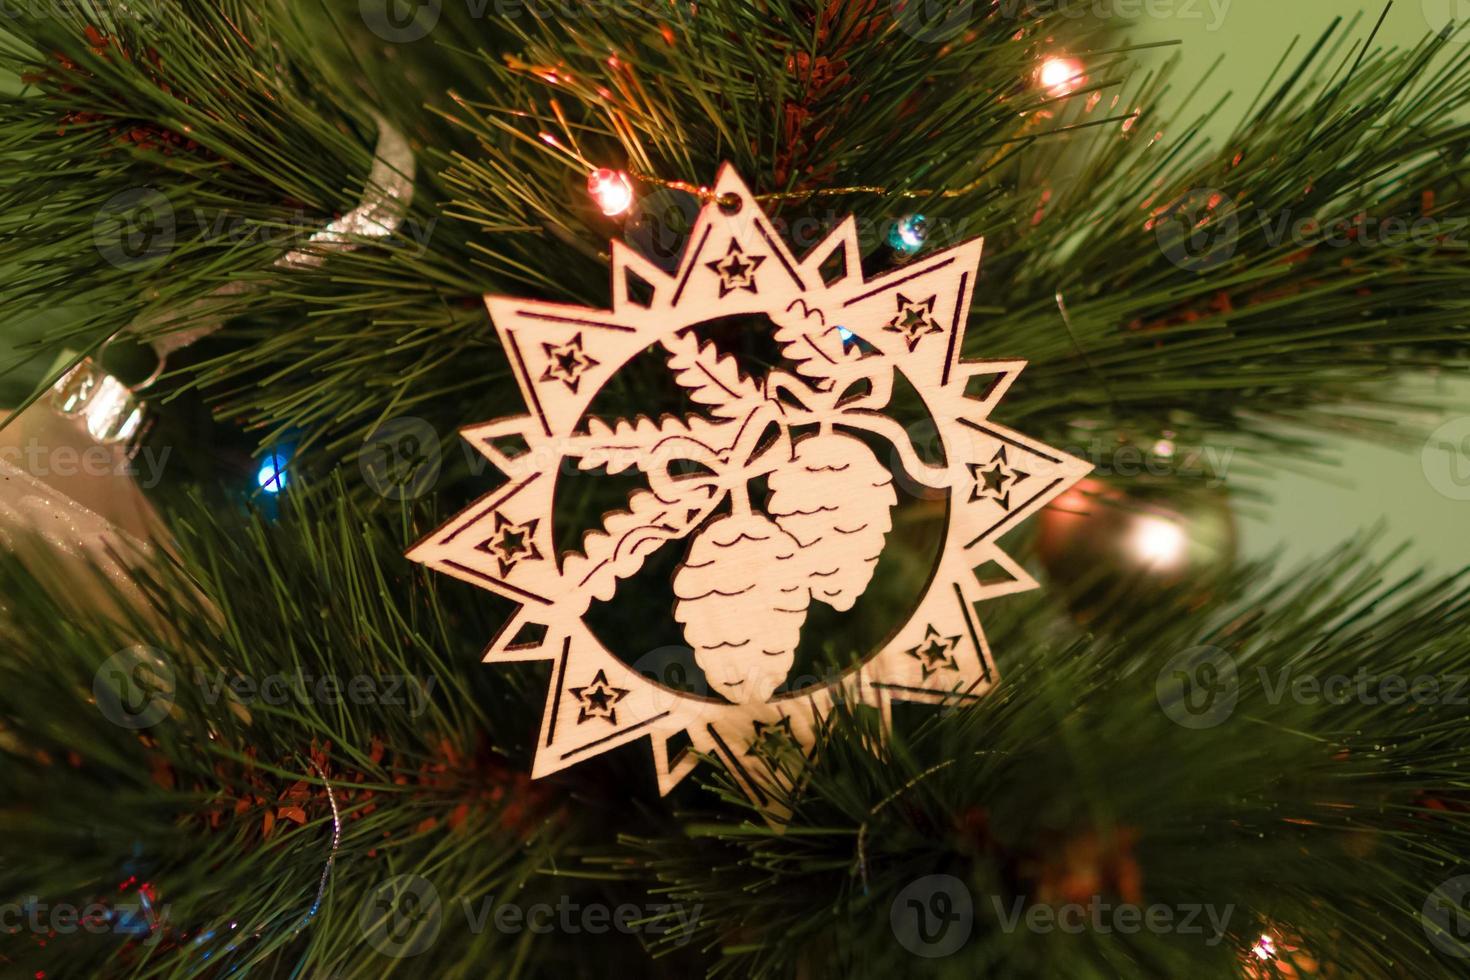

{"left": 766, "top": 432, "right": 898, "bottom": 611}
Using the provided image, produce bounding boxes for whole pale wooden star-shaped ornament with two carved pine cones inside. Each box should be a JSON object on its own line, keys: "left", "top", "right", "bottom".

{"left": 409, "top": 166, "right": 1089, "bottom": 821}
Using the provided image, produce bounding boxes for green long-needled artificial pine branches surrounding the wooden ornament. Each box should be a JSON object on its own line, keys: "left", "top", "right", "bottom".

{"left": 0, "top": 0, "right": 1470, "bottom": 977}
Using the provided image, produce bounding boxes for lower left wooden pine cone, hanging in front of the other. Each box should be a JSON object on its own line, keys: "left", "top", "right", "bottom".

{"left": 673, "top": 513, "right": 811, "bottom": 704}
